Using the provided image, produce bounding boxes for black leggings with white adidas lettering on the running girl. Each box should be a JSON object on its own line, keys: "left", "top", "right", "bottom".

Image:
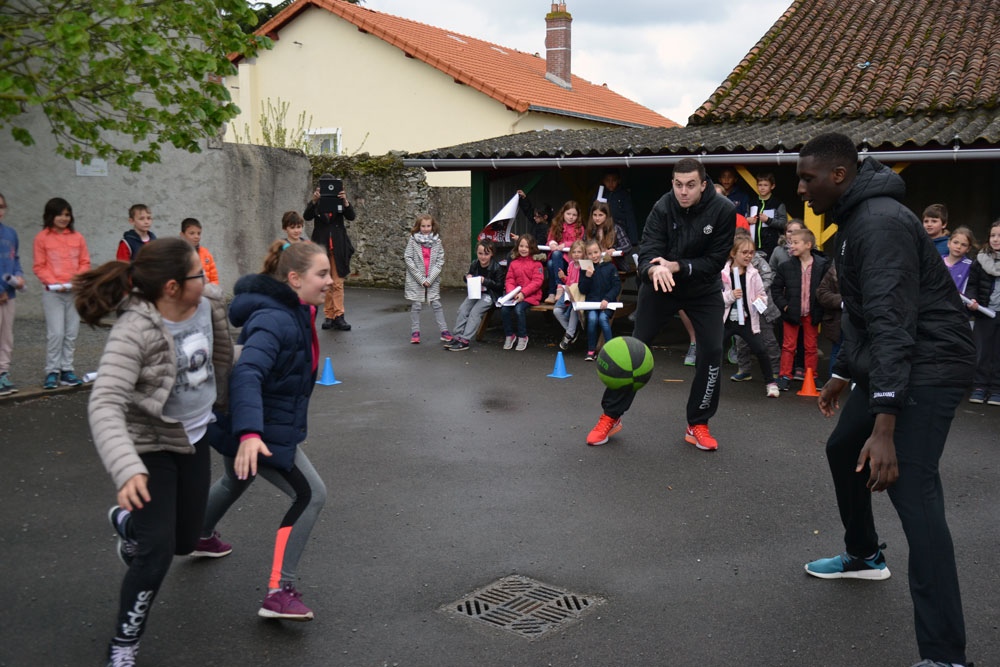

{"left": 115, "top": 438, "right": 211, "bottom": 643}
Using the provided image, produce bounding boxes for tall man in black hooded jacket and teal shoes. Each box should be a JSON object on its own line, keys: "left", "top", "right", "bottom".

{"left": 798, "top": 133, "right": 975, "bottom": 665}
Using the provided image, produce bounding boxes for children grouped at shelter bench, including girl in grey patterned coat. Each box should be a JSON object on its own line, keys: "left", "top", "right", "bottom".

{"left": 404, "top": 198, "right": 632, "bottom": 361}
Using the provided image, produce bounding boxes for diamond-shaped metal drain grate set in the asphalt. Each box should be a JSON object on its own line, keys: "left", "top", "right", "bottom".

{"left": 440, "top": 575, "right": 604, "bottom": 639}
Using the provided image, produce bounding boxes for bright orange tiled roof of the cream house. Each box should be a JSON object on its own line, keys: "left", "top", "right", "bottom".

{"left": 246, "top": 0, "right": 678, "bottom": 127}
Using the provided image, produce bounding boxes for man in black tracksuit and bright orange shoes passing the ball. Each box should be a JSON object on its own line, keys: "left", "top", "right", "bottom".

{"left": 587, "top": 158, "right": 736, "bottom": 451}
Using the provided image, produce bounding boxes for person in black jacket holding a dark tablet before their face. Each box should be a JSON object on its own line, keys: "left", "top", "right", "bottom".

{"left": 302, "top": 174, "right": 354, "bottom": 331}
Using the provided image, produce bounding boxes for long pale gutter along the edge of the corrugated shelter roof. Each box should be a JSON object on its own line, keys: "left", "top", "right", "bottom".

{"left": 403, "top": 148, "right": 1000, "bottom": 171}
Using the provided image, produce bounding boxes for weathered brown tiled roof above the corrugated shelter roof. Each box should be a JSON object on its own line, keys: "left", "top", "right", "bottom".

{"left": 689, "top": 0, "right": 1000, "bottom": 124}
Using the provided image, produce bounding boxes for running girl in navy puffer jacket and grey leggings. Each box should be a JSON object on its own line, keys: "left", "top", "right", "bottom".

{"left": 193, "top": 241, "right": 333, "bottom": 621}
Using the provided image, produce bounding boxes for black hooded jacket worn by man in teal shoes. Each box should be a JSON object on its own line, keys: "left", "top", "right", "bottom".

{"left": 829, "top": 158, "right": 976, "bottom": 414}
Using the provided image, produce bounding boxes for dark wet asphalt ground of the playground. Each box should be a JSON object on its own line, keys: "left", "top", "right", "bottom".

{"left": 0, "top": 288, "right": 1000, "bottom": 667}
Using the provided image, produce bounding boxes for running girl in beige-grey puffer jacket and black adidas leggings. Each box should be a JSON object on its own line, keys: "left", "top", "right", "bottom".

{"left": 74, "top": 238, "right": 233, "bottom": 665}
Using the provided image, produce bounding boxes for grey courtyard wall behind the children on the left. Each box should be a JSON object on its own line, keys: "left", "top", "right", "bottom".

{"left": 0, "top": 109, "right": 471, "bottom": 318}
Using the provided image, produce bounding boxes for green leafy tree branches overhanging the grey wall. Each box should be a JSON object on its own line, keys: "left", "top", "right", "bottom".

{"left": 0, "top": 0, "right": 271, "bottom": 170}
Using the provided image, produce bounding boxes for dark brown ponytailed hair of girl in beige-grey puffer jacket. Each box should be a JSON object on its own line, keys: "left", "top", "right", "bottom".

{"left": 73, "top": 237, "right": 197, "bottom": 325}
